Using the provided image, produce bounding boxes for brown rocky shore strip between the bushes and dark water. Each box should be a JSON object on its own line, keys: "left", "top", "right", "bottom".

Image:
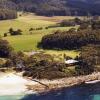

{"left": 27, "top": 72, "right": 100, "bottom": 93}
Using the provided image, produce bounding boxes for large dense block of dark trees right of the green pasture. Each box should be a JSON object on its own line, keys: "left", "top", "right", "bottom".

{"left": 40, "top": 29, "right": 100, "bottom": 50}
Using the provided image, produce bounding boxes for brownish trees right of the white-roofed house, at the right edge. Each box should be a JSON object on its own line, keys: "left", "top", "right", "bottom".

{"left": 76, "top": 45, "right": 100, "bottom": 74}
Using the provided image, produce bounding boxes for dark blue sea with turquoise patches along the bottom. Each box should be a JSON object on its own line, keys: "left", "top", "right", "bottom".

{"left": 0, "top": 83, "right": 100, "bottom": 100}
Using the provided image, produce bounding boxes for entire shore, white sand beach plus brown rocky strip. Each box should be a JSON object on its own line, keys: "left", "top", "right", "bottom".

{"left": 0, "top": 72, "right": 100, "bottom": 96}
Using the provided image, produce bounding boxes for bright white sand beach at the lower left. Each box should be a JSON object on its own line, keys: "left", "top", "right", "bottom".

{"left": 0, "top": 73, "right": 36, "bottom": 95}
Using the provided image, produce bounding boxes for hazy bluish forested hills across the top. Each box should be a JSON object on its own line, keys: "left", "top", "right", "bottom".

{"left": 0, "top": 0, "right": 100, "bottom": 16}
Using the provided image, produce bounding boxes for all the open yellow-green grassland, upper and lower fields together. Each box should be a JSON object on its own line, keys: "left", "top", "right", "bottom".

{"left": 0, "top": 15, "right": 77, "bottom": 57}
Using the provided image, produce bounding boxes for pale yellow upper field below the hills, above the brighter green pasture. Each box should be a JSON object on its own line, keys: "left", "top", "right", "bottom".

{"left": 0, "top": 15, "right": 77, "bottom": 36}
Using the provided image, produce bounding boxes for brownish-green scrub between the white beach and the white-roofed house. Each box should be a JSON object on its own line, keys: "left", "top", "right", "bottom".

{"left": 10, "top": 52, "right": 67, "bottom": 79}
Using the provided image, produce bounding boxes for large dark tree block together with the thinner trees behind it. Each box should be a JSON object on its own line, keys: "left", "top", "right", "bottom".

{"left": 38, "top": 18, "right": 100, "bottom": 50}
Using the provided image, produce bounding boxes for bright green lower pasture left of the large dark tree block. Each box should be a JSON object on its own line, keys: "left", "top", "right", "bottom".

{"left": 4, "top": 34, "right": 43, "bottom": 51}
